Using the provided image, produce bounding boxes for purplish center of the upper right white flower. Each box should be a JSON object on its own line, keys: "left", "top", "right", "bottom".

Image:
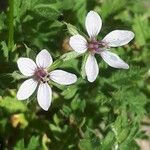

{"left": 88, "top": 39, "right": 107, "bottom": 53}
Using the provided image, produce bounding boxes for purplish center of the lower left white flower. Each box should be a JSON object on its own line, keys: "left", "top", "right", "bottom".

{"left": 34, "top": 68, "right": 49, "bottom": 83}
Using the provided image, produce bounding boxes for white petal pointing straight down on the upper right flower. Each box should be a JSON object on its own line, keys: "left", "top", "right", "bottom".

{"left": 85, "top": 54, "right": 99, "bottom": 82}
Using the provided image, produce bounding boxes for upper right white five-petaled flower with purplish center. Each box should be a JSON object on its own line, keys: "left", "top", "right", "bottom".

{"left": 69, "top": 11, "right": 134, "bottom": 82}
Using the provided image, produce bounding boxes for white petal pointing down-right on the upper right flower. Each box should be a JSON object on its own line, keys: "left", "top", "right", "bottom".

{"left": 101, "top": 50, "right": 129, "bottom": 69}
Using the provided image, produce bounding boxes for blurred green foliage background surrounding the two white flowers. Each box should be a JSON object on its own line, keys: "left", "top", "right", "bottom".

{"left": 0, "top": 0, "right": 150, "bottom": 150}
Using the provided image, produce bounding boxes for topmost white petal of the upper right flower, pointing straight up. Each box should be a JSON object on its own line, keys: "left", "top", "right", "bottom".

{"left": 85, "top": 11, "right": 102, "bottom": 38}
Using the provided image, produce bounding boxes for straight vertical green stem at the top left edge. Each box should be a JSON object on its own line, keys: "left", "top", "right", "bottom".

{"left": 8, "top": 0, "right": 14, "bottom": 51}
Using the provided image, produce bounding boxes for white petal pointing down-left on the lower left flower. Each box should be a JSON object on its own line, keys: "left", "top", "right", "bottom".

{"left": 17, "top": 79, "right": 38, "bottom": 100}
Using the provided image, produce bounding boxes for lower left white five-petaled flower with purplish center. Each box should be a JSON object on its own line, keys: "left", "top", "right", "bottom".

{"left": 17, "top": 49, "right": 77, "bottom": 111}
